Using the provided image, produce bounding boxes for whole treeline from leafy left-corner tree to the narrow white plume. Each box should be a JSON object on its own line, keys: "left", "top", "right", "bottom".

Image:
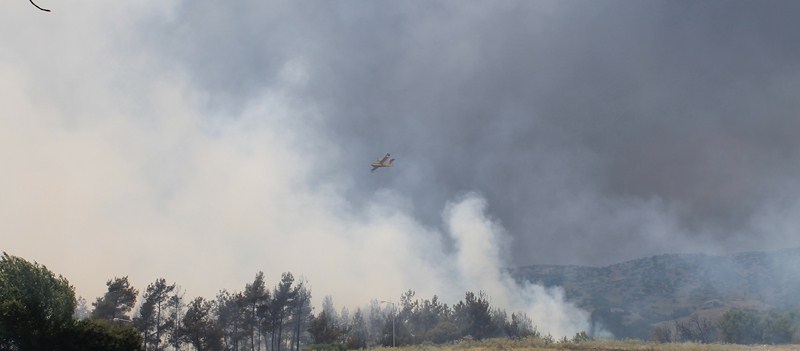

{"left": 0, "top": 253, "right": 539, "bottom": 351}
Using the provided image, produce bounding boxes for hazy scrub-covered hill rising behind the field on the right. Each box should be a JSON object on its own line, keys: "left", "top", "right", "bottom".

{"left": 511, "top": 248, "right": 800, "bottom": 339}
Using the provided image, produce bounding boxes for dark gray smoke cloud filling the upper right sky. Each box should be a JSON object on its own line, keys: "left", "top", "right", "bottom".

{"left": 141, "top": 1, "right": 800, "bottom": 264}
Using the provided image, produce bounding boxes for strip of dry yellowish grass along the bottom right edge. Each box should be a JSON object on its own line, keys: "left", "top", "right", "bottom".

{"left": 368, "top": 338, "right": 800, "bottom": 351}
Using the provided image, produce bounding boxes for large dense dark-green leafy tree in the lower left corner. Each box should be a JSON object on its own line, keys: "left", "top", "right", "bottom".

{"left": 0, "top": 253, "right": 76, "bottom": 350}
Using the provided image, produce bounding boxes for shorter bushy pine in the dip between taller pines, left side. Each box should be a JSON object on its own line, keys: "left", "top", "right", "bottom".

{"left": 180, "top": 297, "right": 222, "bottom": 351}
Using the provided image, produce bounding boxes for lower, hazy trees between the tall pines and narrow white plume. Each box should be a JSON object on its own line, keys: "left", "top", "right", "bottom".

{"left": 309, "top": 290, "right": 539, "bottom": 349}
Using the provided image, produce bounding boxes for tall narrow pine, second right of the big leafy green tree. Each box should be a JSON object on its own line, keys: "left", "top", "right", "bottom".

{"left": 133, "top": 278, "right": 175, "bottom": 350}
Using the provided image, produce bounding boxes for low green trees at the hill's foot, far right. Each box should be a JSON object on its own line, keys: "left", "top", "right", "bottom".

{"left": 653, "top": 309, "right": 800, "bottom": 345}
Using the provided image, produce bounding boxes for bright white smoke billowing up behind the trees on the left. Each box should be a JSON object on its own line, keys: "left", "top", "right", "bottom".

{"left": 0, "top": 1, "right": 608, "bottom": 336}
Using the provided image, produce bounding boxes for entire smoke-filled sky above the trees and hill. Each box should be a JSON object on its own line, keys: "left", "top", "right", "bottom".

{"left": 0, "top": 0, "right": 800, "bottom": 338}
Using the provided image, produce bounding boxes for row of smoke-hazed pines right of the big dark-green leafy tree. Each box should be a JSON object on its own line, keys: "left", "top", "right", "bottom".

{"left": 119, "top": 272, "right": 538, "bottom": 351}
